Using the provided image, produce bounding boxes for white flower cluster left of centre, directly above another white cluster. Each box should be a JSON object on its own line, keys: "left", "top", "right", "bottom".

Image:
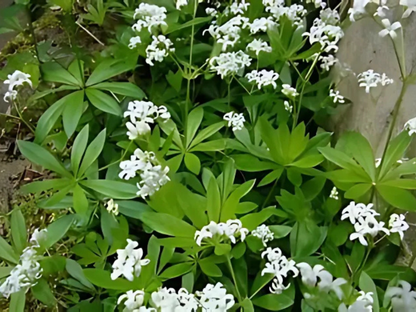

{"left": 124, "top": 101, "right": 170, "bottom": 140}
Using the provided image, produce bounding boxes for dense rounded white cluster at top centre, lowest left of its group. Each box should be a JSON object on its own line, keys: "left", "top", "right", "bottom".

{"left": 209, "top": 51, "right": 251, "bottom": 79}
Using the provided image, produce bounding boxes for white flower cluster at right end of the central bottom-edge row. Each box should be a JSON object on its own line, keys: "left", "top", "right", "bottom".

{"left": 197, "top": 283, "right": 235, "bottom": 312}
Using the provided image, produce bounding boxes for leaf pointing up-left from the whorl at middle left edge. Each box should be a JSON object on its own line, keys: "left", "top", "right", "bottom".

{"left": 17, "top": 140, "right": 72, "bottom": 178}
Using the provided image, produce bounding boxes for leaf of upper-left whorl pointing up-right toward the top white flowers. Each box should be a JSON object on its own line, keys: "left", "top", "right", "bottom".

{"left": 85, "top": 58, "right": 136, "bottom": 86}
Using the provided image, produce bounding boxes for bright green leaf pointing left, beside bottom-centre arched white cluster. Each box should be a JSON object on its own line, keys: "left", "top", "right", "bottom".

{"left": 141, "top": 212, "right": 196, "bottom": 237}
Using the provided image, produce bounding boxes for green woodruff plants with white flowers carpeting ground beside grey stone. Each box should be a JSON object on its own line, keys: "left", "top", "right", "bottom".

{"left": 0, "top": 0, "right": 416, "bottom": 312}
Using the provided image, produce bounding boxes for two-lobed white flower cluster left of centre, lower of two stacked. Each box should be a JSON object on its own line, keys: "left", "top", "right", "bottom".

{"left": 119, "top": 148, "right": 170, "bottom": 198}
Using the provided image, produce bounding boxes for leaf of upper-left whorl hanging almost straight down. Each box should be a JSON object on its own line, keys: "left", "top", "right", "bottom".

{"left": 62, "top": 91, "right": 84, "bottom": 138}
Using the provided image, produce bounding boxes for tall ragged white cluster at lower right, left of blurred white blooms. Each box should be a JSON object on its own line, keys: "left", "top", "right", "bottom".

{"left": 261, "top": 247, "right": 299, "bottom": 294}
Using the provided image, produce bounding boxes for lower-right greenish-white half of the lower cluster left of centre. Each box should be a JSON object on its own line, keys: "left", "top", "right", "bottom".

{"left": 137, "top": 165, "right": 170, "bottom": 198}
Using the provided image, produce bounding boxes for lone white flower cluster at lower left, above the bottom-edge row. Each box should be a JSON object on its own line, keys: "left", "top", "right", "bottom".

{"left": 111, "top": 239, "right": 150, "bottom": 281}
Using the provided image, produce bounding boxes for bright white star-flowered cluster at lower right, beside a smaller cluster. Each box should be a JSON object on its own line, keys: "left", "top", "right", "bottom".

{"left": 341, "top": 201, "right": 403, "bottom": 246}
